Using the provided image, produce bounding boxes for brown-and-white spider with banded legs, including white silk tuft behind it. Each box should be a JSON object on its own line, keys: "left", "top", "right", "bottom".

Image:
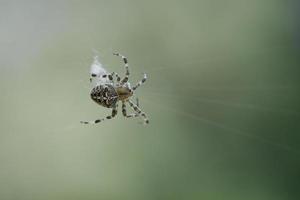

{"left": 80, "top": 53, "right": 149, "bottom": 124}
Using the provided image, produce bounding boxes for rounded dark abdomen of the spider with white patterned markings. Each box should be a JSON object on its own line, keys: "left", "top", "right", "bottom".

{"left": 91, "top": 84, "right": 119, "bottom": 108}
